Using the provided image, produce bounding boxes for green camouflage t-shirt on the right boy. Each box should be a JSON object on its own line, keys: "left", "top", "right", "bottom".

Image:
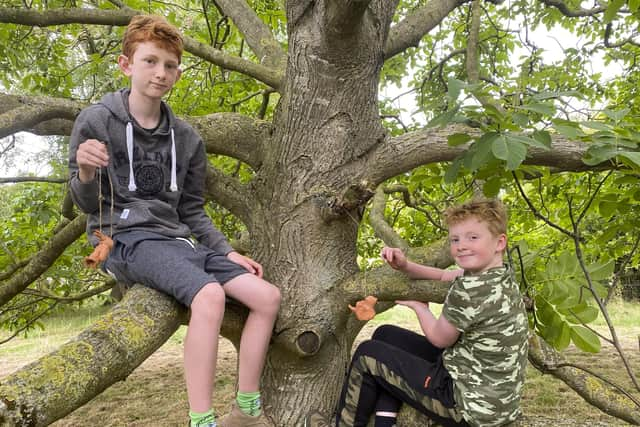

{"left": 442, "top": 267, "right": 528, "bottom": 426}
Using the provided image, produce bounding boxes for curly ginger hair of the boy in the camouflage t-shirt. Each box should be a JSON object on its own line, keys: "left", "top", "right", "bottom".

{"left": 444, "top": 199, "right": 507, "bottom": 236}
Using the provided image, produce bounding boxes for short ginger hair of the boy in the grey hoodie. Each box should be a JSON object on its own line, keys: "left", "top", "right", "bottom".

{"left": 122, "top": 15, "right": 184, "bottom": 62}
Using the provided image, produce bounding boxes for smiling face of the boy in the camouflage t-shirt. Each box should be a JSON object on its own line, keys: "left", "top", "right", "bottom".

{"left": 449, "top": 217, "right": 507, "bottom": 274}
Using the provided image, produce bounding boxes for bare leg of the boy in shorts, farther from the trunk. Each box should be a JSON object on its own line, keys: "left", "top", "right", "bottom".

{"left": 184, "top": 283, "right": 225, "bottom": 412}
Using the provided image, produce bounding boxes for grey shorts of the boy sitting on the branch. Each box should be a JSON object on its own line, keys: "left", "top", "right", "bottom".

{"left": 103, "top": 233, "right": 249, "bottom": 307}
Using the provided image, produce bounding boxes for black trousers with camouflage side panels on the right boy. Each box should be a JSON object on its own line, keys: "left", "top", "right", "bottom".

{"left": 336, "top": 325, "right": 468, "bottom": 427}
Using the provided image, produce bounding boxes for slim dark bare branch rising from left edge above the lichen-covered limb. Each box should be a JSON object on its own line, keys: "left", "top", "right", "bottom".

{"left": 0, "top": 215, "right": 87, "bottom": 307}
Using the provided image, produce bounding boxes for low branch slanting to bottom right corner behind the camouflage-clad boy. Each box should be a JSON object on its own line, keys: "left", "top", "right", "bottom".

{"left": 529, "top": 335, "right": 640, "bottom": 425}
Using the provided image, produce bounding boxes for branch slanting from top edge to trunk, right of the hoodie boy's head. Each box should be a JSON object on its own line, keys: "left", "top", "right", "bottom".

{"left": 216, "top": 0, "right": 287, "bottom": 70}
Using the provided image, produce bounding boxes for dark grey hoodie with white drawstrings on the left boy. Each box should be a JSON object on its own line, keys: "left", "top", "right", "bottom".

{"left": 69, "top": 89, "right": 232, "bottom": 254}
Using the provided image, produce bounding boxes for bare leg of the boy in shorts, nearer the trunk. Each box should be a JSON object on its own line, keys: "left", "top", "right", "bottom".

{"left": 224, "top": 274, "right": 280, "bottom": 392}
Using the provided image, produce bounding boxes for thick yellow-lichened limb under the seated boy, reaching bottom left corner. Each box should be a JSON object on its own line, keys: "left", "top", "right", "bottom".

{"left": 0, "top": 286, "right": 186, "bottom": 426}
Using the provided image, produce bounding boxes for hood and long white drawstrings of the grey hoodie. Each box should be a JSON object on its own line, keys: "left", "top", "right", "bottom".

{"left": 100, "top": 89, "right": 178, "bottom": 192}
